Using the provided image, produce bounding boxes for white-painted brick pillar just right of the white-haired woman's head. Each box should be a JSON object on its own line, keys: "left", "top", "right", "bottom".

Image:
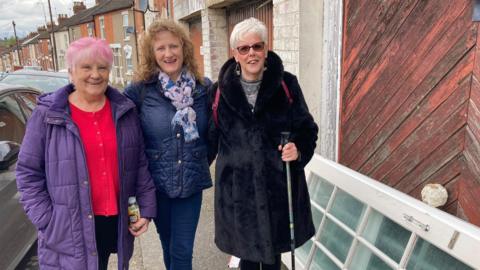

{"left": 273, "top": 0, "right": 300, "bottom": 76}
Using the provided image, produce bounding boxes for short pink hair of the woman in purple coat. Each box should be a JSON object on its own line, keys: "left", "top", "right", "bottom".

{"left": 66, "top": 37, "right": 113, "bottom": 69}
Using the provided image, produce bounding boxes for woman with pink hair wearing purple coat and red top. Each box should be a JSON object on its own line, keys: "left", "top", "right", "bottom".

{"left": 17, "top": 38, "right": 156, "bottom": 270}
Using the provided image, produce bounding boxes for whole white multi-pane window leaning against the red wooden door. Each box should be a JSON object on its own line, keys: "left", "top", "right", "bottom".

{"left": 283, "top": 156, "right": 480, "bottom": 270}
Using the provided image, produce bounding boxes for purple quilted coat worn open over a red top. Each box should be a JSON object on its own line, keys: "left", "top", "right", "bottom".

{"left": 17, "top": 84, "right": 156, "bottom": 270}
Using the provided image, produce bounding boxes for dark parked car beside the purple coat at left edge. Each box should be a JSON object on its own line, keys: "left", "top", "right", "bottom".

{"left": 0, "top": 83, "right": 40, "bottom": 270}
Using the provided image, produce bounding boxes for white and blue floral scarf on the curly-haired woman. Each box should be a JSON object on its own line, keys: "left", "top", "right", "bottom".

{"left": 158, "top": 68, "right": 199, "bottom": 142}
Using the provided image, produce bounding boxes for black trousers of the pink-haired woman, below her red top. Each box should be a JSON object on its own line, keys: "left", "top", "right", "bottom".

{"left": 95, "top": 216, "right": 118, "bottom": 270}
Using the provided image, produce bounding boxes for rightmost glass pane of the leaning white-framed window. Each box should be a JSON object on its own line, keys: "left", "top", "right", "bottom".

{"left": 407, "top": 238, "right": 473, "bottom": 270}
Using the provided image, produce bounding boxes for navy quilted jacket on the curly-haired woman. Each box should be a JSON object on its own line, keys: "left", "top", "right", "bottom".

{"left": 125, "top": 76, "right": 212, "bottom": 198}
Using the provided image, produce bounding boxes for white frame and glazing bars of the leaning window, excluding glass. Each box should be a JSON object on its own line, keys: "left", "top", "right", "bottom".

{"left": 282, "top": 154, "right": 480, "bottom": 270}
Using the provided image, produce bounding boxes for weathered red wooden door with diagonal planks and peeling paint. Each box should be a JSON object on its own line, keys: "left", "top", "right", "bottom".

{"left": 339, "top": 0, "right": 480, "bottom": 225}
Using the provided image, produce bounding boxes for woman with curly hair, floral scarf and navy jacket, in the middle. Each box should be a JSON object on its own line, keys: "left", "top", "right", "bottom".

{"left": 125, "top": 20, "right": 212, "bottom": 270}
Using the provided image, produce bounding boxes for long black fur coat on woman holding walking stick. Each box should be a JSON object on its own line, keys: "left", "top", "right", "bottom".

{"left": 208, "top": 52, "right": 318, "bottom": 264}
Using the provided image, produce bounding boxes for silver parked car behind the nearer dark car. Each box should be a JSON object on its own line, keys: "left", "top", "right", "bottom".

{"left": 0, "top": 69, "right": 69, "bottom": 93}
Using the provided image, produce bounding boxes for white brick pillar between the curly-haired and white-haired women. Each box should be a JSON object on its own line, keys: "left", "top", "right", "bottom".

{"left": 201, "top": 8, "right": 229, "bottom": 82}
